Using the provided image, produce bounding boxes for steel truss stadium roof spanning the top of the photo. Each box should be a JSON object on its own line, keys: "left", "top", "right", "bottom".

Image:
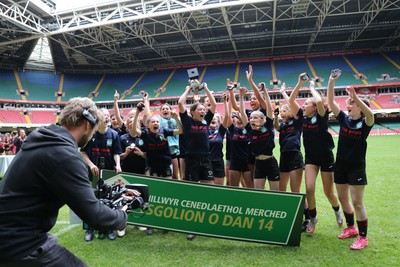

{"left": 0, "top": 0, "right": 400, "bottom": 73}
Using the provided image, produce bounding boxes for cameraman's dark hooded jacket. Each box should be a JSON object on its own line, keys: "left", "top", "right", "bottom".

{"left": 0, "top": 125, "right": 127, "bottom": 259}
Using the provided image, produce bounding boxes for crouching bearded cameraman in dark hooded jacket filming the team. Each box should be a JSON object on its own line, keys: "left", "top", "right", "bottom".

{"left": 0, "top": 98, "right": 131, "bottom": 266}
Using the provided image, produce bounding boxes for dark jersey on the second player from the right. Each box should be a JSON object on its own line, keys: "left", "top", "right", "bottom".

{"left": 298, "top": 109, "right": 335, "bottom": 156}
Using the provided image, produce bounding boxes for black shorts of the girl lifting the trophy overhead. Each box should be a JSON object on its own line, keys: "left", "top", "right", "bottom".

{"left": 185, "top": 155, "right": 214, "bottom": 182}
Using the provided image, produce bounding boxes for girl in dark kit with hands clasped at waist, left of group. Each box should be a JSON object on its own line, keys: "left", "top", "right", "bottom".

{"left": 120, "top": 118, "right": 150, "bottom": 175}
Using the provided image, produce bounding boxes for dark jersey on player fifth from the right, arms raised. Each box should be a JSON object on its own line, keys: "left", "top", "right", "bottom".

{"left": 227, "top": 124, "right": 250, "bottom": 162}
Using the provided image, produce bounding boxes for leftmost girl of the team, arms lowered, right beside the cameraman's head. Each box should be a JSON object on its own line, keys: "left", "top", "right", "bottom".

{"left": 81, "top": 108, "right": 125, "bottom": 242}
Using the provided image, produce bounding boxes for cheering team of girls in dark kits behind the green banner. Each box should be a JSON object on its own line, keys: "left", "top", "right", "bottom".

{"left": 112, "top": 66, "right": 374, "bottom": 250}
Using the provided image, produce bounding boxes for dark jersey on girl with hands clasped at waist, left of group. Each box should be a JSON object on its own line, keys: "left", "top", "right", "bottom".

{"left": 121, "top": 133, "right": 146, "bottom": 174}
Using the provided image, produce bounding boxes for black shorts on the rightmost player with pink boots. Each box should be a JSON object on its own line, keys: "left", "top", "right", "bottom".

{"left": 334, "top": 159, "right": 367, "bottom": 185}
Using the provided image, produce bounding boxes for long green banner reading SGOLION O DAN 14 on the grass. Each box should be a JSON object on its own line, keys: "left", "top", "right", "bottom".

{"left": 103, "top": 170, "right": 305, "bottom": 246}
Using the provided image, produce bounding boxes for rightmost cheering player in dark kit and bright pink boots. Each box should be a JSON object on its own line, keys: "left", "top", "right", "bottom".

{"left": 328, "top": 74, "right": 374, "bottom": 250}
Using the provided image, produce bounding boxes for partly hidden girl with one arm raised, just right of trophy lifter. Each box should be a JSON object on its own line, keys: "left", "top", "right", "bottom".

{"left": 208, "top": 95, "right": 230, "bottom": 185}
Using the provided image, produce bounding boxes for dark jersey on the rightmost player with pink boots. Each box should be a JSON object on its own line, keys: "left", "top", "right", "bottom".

{"left": 336, "top": 111, "right": 372, "bottom": 163}
